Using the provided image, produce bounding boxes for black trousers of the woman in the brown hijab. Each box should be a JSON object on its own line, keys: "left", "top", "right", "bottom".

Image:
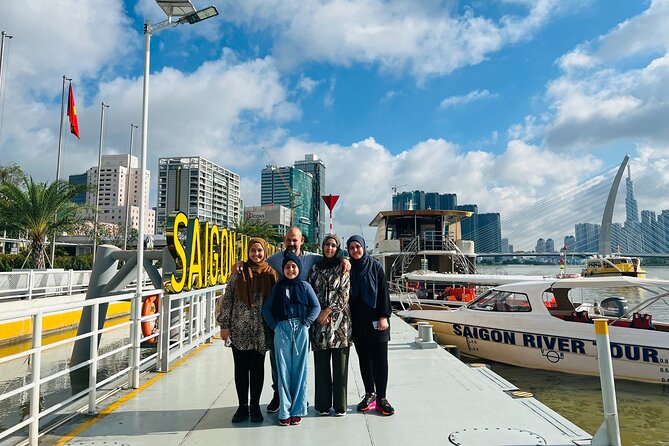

{"left": 232, "top": 345, "right": 265, "bottom": 406}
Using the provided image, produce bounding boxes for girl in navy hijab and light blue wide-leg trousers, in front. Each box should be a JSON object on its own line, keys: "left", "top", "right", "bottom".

{"left": 262, "top": 253, "right": 321, "bottom": 426}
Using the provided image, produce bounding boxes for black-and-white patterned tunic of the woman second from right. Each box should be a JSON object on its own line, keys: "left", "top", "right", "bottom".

{"left": 309, "top": 264, "right": 351, "bottom": 350}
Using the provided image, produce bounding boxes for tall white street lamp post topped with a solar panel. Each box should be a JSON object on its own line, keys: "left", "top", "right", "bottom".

{"left": 131, "top": 0, "right": 218, "bottom": 389}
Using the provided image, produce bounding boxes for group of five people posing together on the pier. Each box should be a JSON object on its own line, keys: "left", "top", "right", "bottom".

{"left": 216, "top": 227, "right": 395, "bottom": 426}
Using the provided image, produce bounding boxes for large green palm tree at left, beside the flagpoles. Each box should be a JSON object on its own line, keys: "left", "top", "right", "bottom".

{"left": 0, "top": 176, "right": 87, "bottom": 269}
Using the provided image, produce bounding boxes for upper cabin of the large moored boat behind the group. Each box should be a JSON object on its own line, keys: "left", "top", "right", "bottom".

{"left": 369, "top": 209, "right": 476, "bottom": 280}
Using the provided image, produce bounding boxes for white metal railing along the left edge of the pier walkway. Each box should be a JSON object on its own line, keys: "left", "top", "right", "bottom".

{"left": 0, "top": 285, "right": 225, "bottom": 445}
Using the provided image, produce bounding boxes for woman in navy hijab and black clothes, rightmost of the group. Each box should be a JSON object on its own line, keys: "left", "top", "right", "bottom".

{"left": 346, "top": 235, "right": 395, "bottom": 415}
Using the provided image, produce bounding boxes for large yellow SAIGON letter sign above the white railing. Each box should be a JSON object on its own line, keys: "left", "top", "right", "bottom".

{"left": 163, "top": 212, "right": 276, "bottom": 293}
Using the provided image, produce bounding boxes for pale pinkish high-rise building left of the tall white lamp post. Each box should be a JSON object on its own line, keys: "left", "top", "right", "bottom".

{"left": 79, "top": 155, "right": 156, "bottom": 235}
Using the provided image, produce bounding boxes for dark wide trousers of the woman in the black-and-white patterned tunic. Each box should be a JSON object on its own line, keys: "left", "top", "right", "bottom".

{"left": 314, "top": 347, "right": 349, "bottom": 413}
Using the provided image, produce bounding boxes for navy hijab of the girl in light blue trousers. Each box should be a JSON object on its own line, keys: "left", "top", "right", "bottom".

{"left": 272, "top": 252, "right": 309, "bottom": 321}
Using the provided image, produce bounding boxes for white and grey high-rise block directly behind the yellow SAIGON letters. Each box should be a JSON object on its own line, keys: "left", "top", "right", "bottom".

{"left": 157, "top": 156, "right": 242, "bottom": 232}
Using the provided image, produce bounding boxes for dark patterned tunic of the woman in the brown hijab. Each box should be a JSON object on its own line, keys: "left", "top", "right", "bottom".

{"left": 216, "top": 275, "right": 272, "bottom": 353}
